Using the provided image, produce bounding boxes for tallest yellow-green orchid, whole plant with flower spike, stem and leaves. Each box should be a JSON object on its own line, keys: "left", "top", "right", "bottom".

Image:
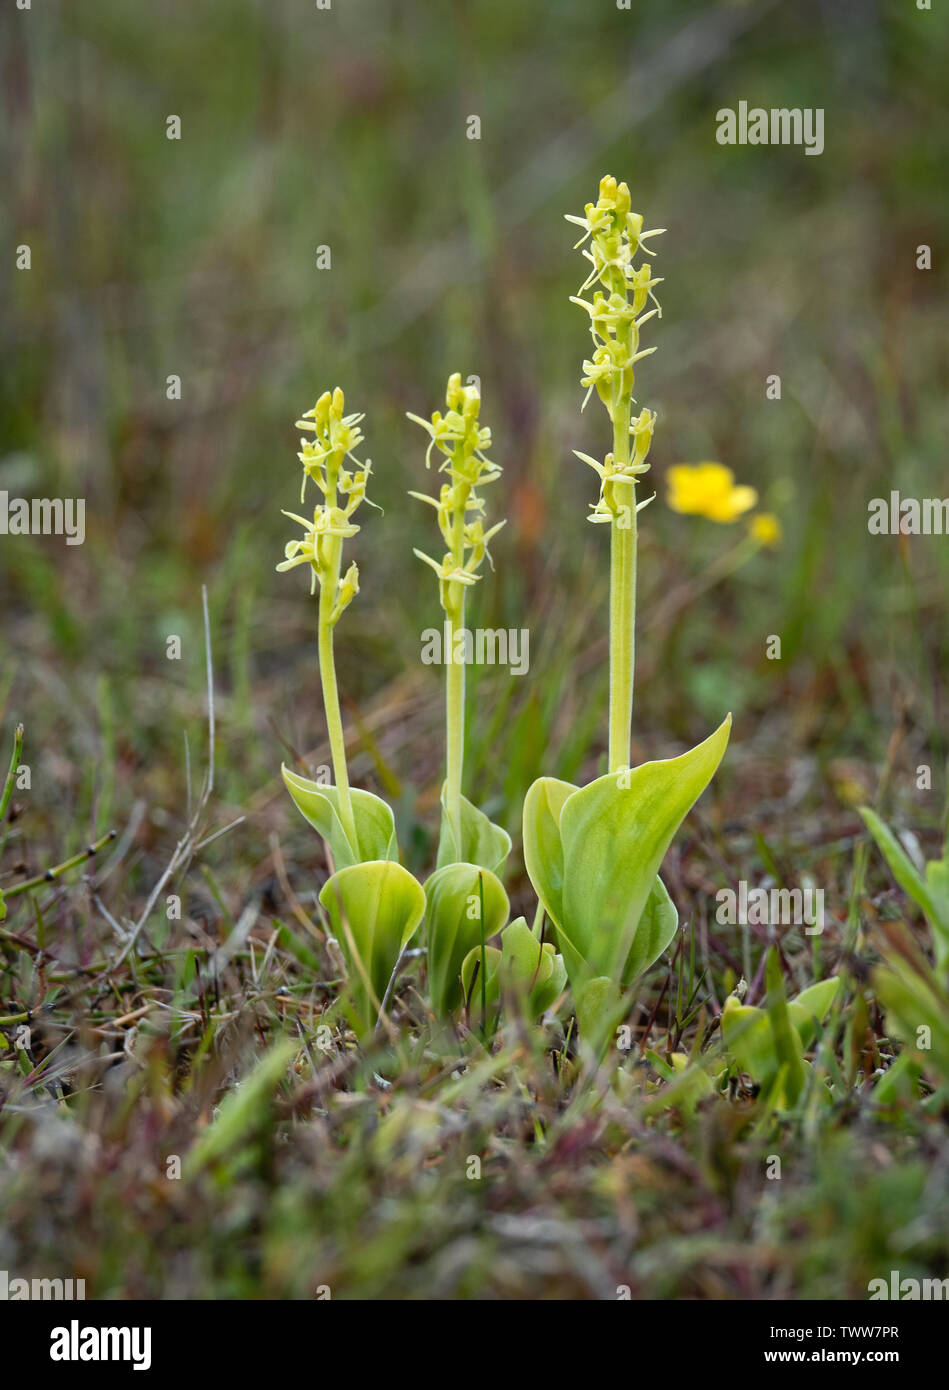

{"left": 524, "top": 177, "right": 731, "bottom": 1041}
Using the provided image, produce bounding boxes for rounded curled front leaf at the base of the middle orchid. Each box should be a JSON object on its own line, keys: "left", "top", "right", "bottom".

{"left": 425, "top": 863, "right": 509, "bottom": 1019}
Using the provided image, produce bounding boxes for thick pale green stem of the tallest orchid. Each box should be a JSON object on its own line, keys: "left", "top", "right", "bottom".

{"left": 610, "top": 405, "right": 636, "bottom": 773}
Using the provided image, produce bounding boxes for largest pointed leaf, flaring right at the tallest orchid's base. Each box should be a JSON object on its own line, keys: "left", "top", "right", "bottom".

{"left": 560, "top": 714, "right": 731, "bottom": 984}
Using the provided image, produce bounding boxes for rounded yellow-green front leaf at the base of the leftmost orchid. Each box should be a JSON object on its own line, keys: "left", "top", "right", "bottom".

{"left": 320, "top": 859, "right": 425, "bottom": 1037}
